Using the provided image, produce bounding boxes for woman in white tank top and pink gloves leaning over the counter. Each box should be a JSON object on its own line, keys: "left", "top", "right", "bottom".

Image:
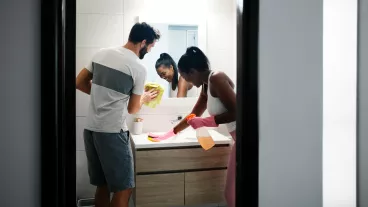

{"left": 149, "top": 47, "right": 236, "bottom": 207}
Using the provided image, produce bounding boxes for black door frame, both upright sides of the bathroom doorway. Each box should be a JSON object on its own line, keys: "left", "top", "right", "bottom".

{"left": 41, "top": 0, "right": 259, "bottom": 207}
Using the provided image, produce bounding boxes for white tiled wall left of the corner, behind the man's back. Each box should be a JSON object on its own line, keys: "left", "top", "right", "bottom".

{"left": 76, "top": 0, "right": 124, "bottom": 198}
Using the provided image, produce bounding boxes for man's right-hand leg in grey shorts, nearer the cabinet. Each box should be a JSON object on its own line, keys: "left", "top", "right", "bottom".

{"left": 95, "top": 131, "right": 135, "bottom": 207}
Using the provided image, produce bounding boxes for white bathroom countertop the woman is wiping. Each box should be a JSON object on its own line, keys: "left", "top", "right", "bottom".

{"left": 130, "top": 129, "right": 232, "bottom": 149}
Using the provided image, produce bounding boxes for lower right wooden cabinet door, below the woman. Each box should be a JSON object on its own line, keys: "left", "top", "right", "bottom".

{"left": 185, "top": 170, "right": 226, "bottom": 205}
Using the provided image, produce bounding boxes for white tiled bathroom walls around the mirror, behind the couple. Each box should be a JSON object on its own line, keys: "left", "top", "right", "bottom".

{"left": 76, "top": 0, "right": 236, "bottom": 198}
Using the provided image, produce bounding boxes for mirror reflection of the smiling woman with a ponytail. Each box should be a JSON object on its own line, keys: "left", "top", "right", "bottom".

{"left": 155, "top": 53, "right": 198, "bottom": 98}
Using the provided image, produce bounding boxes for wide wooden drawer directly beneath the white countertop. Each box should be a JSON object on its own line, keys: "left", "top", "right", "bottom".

{"left": 135, "top": 146, "right": 230, "bottom": 173}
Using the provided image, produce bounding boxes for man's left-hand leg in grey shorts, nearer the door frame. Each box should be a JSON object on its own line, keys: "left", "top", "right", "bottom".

{"left": 83, "top": 130, "right": 110, "bottom": 207}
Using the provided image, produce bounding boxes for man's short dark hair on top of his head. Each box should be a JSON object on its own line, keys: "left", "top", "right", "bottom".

{"left": 128, "top": 22, "right": 161, "bottom": 45}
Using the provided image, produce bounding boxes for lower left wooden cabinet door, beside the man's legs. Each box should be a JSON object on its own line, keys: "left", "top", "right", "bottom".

{"left": 136, "top": 173, "right": 184, "bottom": 207}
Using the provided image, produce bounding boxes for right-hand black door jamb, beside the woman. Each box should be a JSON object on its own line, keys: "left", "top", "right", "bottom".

{"left": 236, "top": 0, "right": 259, "bottom": 207}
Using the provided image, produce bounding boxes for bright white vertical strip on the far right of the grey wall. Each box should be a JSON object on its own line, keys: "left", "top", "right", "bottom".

{"left": 323, "top": 0, "right": 358, "bottom": 207}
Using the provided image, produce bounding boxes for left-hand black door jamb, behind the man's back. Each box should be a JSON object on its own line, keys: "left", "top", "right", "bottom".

{"left": 41, "top": 0, "right": 76, "bottom": 207}
